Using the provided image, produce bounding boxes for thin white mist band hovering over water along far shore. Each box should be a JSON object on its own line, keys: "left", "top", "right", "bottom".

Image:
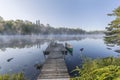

{"left": 0, "top": 34, "right": 104, "bottom": 42}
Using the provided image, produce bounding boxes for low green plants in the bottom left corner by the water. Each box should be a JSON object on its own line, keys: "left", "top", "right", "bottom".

{"left": 0, "top": 73, "right": 26, "bottom": 80}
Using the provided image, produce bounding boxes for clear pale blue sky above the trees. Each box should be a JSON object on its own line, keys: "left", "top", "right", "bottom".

{"left": 0, "top": 0, "right": 120, "bottom": 31}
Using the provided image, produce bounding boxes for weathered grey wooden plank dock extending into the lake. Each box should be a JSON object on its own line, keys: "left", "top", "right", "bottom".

{"left": 37, "top": 43, "right": 70, "bottom": 80}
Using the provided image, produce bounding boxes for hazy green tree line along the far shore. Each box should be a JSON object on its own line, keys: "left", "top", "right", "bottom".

{"left": 0, "top": 16, "right": 86, "bottom": 35}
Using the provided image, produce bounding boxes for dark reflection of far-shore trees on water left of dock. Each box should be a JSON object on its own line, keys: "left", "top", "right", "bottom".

{"left": 0, "top": 39, "right": 47, "bottom": 51}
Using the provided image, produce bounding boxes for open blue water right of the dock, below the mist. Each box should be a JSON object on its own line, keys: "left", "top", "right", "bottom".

{"left": 63, "top": 38, "right": 118, "bottom": 76}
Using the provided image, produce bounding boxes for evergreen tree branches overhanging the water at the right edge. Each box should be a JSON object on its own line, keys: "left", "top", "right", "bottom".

{"left": 105, "top": 6, "right": 120, "bottom": 45}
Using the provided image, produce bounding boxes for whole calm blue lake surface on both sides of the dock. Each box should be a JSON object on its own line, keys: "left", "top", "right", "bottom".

{"left": 0, "top": 35, "right": 119, "bottom": 80}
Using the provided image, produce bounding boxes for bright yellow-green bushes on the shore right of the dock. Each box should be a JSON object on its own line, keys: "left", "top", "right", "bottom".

{"left": 71, "top": 57, "right": 120, "bottom": 80}
